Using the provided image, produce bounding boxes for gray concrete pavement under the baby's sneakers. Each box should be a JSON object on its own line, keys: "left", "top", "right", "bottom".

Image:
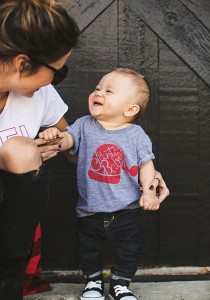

{"left": 24, "top": 281, "right": 210, "bottom": 300}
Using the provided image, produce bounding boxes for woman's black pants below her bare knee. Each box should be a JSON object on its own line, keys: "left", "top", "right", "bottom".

{"left": 0, "top": 166, "right": 48, "bottom": 300}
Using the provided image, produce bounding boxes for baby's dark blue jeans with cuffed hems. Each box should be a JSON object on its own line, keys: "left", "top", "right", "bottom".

{"left": 77, "top": 209, "right": 143, "bottom": 280}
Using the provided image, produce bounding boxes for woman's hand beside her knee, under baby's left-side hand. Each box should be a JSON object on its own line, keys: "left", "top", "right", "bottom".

{"left": 34, "top": 138, "right": 60, "bottom": 161}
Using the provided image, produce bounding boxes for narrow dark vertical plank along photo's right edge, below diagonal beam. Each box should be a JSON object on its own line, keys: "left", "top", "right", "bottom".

{"left": 197, "top": 82, "right": 210, "bottom": 265}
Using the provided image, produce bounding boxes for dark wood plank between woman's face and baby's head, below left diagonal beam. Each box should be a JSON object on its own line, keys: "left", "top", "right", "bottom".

{"left": 57, "top": 1, "right": 118, "bottom": 123}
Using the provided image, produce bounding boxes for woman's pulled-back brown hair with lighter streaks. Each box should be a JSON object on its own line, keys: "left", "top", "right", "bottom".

{"left": 0, "top": 0, "right": 79, "bottom": 63}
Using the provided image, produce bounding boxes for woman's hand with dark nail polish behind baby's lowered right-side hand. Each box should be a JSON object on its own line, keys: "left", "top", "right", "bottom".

{"left": 149, "top": 171, "right": 170, "bottom": 203}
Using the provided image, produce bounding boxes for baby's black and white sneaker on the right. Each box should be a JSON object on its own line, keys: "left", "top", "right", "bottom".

{"left": 108, "top": 279, "right": 137, "bottom": 300}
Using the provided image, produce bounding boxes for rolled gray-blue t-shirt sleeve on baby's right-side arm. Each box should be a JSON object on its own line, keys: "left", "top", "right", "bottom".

{"left": 137, "top": 130, "right": 155, "bottom": 166}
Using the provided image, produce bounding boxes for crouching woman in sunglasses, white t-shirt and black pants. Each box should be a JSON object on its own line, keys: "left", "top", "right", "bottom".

{"left": 0, "top": 0, "right": 79, "bottom": 300}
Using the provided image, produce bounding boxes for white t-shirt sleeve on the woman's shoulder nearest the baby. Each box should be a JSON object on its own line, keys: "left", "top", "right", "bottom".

{"left": 40, "top": 84, "right": 68, "bottom": 127}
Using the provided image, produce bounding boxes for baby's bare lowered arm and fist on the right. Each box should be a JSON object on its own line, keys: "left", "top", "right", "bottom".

{"left": 140, "top": 160, "right": 160, "bottom": 210}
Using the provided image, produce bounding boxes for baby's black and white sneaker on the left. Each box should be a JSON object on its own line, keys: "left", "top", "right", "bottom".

{"left": 80, "top": 275, "right": 104, "bottom": 300}
